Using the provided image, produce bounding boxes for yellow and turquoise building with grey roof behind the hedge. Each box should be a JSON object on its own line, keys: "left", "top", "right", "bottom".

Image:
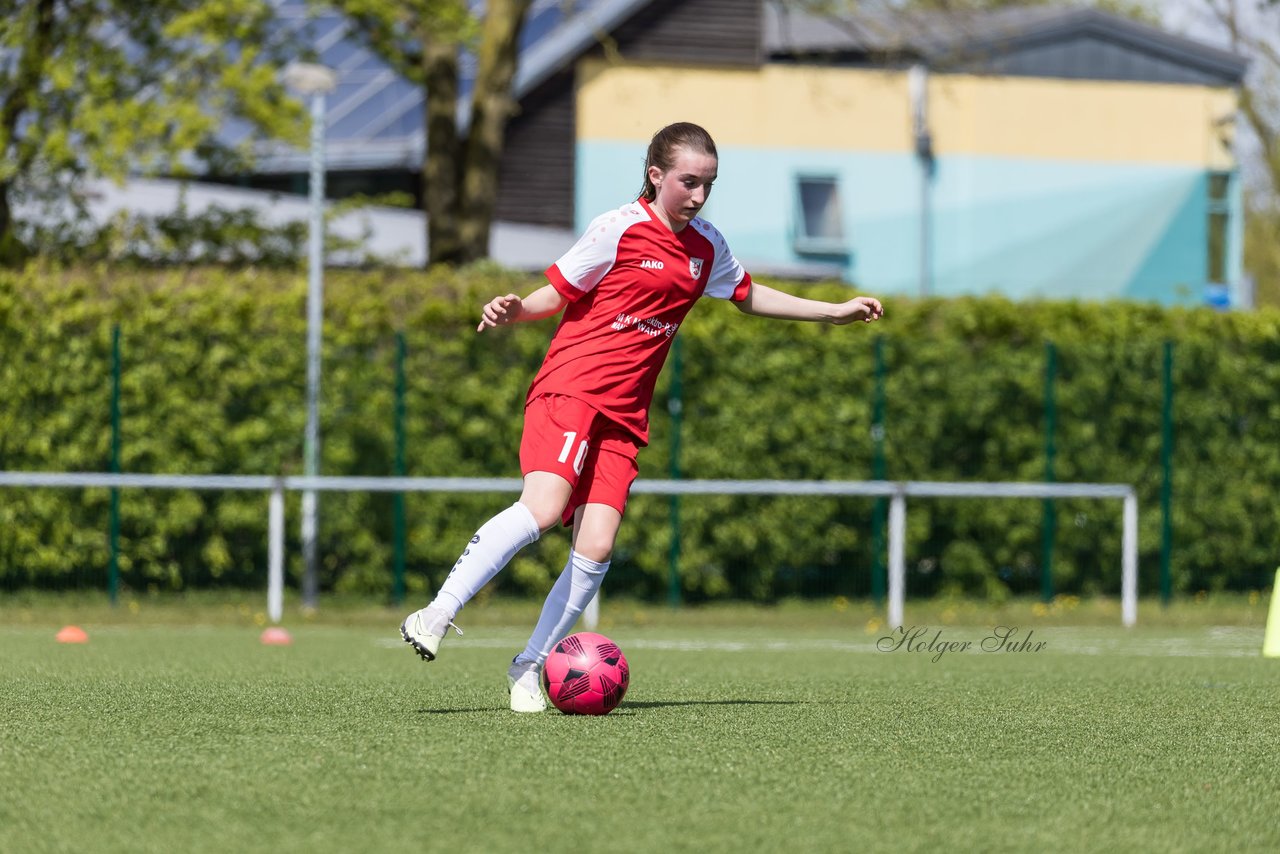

{"left": 524, "top": 4, "right": 1244, "bottom": 303}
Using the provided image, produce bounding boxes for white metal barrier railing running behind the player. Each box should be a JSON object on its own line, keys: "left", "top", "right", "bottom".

{"left": 0, "top": 471, "right": 1138, "bottom": 629}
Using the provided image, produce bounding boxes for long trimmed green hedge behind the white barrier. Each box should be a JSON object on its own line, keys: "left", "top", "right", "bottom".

{"left": 0, "top": 268, "right": 1280, "bottom": 600}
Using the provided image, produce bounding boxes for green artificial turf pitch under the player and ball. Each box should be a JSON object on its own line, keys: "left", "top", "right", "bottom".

{"left": 0, "top": 600, "right": 1280, "bottom": 854}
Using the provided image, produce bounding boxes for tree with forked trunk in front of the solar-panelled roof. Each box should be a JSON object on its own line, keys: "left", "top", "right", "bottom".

{"left": 326, "top": 0, "right": 532, "bottom": 264}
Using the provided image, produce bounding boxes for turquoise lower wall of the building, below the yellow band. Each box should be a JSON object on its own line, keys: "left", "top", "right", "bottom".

{"left": 576, "top": 141, "right": 1242, "bottom": 305}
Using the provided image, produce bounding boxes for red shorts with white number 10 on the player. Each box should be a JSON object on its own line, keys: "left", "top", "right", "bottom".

{"left": 520, "top": 394, "right": 640, "bottom": 525}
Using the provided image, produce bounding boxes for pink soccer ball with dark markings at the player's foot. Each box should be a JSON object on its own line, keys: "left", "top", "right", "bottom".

{"left": 543, "top": 631, "right": 631, "bottom": 714}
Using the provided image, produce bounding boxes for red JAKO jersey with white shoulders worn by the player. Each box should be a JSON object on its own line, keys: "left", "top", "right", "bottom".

{"left": 529, "top": 198, "right": 751, "bottom": 444}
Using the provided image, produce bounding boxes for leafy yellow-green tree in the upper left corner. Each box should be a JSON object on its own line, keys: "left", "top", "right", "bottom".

{"left": 0, "top": 0, "right": 306, "bottom": 265}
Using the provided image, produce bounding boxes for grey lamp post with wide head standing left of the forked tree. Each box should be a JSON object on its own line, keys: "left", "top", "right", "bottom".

{"left": 284, "top": 63, "right": 337, "bottom": 608}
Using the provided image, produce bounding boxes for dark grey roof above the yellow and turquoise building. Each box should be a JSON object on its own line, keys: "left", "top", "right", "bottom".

{"left": 764, "top": 0, "right": 1248, "bottom": 86}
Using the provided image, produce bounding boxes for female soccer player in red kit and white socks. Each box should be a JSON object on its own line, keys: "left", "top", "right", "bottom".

{"left": 401, "top": 123, "right": 883, "bottom": 712}
